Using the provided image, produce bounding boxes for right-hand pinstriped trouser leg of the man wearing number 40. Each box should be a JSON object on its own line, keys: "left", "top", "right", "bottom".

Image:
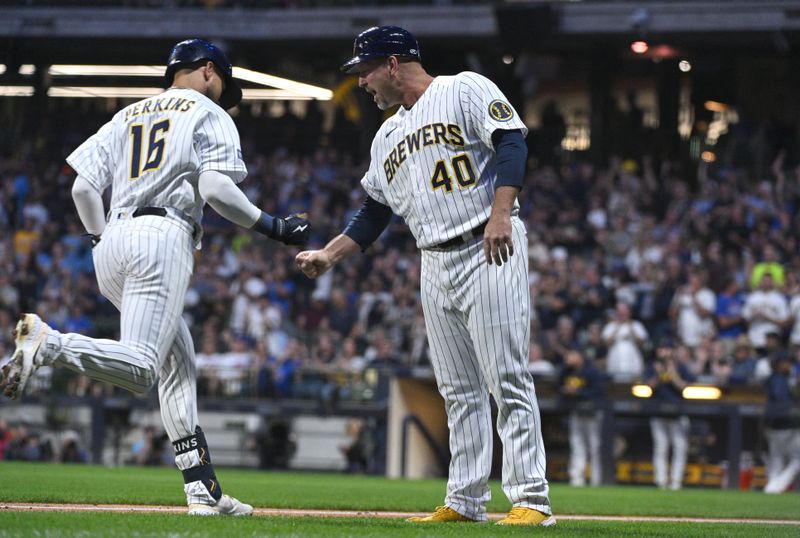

{"left": 464, "top": 217, "right": 555, "bottom": 524}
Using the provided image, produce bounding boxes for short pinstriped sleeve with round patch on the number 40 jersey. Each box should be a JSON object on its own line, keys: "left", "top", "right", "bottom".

{"left": 458, "top": 71, "right": 528, "bottom": 148}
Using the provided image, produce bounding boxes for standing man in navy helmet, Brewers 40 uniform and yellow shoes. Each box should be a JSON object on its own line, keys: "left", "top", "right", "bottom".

{"left": 296, "top": 26, "right": 555, "bottom": 525}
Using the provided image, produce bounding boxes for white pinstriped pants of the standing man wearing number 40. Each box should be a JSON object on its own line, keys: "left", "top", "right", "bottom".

{"left": 421, "top": 217, "right": 552, "bottom": 521}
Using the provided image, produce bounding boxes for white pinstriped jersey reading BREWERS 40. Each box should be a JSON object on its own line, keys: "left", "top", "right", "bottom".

{"left": 361, "top": 72, "right": 527, "bottom": 248}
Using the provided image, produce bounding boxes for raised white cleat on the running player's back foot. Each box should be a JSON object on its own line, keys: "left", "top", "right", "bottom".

{"left": 0, "top": 314, "right": 50, "bottom": 400}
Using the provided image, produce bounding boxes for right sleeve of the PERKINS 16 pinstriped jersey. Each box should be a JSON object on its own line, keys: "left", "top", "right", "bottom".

{"left": 194, "top": 109, "right": 247, "bottom": 183}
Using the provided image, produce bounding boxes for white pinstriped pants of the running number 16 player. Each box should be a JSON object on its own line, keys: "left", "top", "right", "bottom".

{"left": 48, "top": 210, "right": 198, "bottom": 441}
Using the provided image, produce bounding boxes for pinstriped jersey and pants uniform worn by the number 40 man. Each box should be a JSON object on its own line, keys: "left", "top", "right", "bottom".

{"left": 361, "top": 72, "right": 552, "bottom": 521}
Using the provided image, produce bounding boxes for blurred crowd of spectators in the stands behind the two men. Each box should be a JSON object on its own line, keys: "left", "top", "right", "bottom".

{"left": 0, "top": 96, "right": 800, "bottom": 399}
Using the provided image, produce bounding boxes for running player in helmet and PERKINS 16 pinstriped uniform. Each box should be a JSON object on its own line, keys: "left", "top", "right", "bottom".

{"left": 0, "top": 39, "right": 309, "bottom": 516}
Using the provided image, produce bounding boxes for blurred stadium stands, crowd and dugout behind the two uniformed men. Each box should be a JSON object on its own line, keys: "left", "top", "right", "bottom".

{"left": 0, "top": 0, "right": 800, "bottom": 489}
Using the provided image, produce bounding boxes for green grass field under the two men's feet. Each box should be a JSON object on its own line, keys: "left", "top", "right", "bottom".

{"left": 0, "top": 462, "right": 800, "bottom": 538}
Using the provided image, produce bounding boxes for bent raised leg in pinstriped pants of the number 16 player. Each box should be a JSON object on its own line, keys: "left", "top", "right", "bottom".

{"left": 47, "top": 217, "right": 193, "bottom": 393}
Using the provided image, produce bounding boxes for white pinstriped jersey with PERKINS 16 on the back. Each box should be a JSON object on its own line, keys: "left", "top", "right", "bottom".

{"left": 67, "top": 88, "right": 247, "bottom": 223}
